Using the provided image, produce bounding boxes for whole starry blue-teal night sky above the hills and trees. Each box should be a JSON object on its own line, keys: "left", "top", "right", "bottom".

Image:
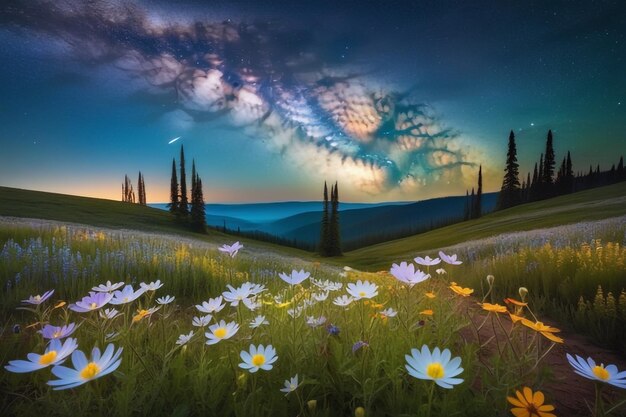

{"left": 0, "top": 0, "right": 626, "bottom": 202}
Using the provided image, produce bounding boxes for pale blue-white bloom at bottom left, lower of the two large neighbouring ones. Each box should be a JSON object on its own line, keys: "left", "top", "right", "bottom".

{"left": 48, "top": 343, "right": 123, "bottom": 390}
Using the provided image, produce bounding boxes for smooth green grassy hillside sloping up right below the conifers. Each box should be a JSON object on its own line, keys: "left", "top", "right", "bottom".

{"left": 338, "top": 182, "right": 626, "bottom": 271}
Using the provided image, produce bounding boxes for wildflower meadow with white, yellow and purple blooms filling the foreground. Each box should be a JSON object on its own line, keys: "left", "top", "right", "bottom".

{"left": 0, "top": 219, "right": 626, "bottom": 417}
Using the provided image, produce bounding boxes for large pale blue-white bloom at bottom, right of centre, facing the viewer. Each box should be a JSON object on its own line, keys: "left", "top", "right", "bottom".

{"left": 405, "top": 345, "right": 463, "bottom": 389}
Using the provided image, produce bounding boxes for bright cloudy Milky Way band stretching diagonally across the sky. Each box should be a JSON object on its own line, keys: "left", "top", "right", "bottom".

{"left": 0, "top": 0, "right": 474, "bottom": 194}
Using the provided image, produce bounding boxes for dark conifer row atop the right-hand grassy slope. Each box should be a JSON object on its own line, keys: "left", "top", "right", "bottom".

{"left": 496, "top": 130, "right": 626, "bottom": 210}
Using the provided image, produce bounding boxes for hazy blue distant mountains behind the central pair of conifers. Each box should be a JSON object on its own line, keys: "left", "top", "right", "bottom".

{"left": 150, "top": 193, "right": 498, "bottom": 249}
